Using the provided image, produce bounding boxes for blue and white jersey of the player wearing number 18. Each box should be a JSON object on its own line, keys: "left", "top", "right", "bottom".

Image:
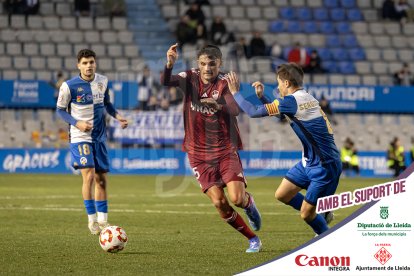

{"left": 57, "top": 74, "right": 114, "bottom": 143}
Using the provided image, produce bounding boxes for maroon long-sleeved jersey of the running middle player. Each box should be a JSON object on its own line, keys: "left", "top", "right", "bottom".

{"left": 161, "top": 68, "right": 243, "bottom": 160}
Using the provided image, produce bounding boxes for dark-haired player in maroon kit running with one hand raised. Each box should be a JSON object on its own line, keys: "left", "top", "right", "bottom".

{"left": 161, "top": 44, "right": 262, "bottom": 253}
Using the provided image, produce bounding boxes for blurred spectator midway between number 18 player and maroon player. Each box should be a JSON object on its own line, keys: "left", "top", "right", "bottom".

{"left": 137, "top": 65, "right": 154, "bottom": 111}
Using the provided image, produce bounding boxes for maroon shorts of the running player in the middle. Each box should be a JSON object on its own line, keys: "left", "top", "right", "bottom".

{"left": 188, "top": 151, "right": 246, "bottom": 193}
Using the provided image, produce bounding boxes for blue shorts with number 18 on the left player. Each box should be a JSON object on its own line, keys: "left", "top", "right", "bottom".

{"left": 70, "top": 142, "right": 109, "bottom": 172}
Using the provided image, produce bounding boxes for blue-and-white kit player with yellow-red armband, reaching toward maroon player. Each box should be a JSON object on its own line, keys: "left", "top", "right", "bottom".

{"left": 226, "top": 63, "right": 342, "bottom": 235}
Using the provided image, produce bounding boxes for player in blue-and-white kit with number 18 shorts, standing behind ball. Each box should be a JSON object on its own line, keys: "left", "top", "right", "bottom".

{"left": 56, "top": 49, "right": 128, "bottom": 235}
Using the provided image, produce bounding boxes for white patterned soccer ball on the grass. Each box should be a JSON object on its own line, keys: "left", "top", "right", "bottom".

{"left": 99, "top": 225, "right": 128, "bottom": 253}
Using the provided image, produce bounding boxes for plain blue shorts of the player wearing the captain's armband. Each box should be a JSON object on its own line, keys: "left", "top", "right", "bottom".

{"left": 285, "top": 160, "right": 342, "bottom": 206}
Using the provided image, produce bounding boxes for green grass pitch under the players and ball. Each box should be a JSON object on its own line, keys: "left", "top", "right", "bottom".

{"left": 0, "top": 174, "right": 387, "bottom": 275}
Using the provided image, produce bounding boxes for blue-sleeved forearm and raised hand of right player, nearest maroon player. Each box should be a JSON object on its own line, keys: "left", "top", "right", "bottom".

{"left": 225, "top": 72, "right": 269, "bottom": 118}
